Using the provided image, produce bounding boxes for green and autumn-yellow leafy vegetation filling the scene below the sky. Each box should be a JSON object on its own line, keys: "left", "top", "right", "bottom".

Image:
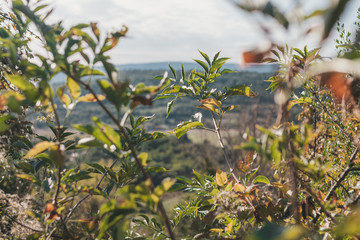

{"left": 0, "top": 0, "right": 360, "bottom": 239}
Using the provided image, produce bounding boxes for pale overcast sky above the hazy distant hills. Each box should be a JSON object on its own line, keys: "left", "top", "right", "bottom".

{"left": 39, "top": 0, "right": 360, "bottom": 64}
